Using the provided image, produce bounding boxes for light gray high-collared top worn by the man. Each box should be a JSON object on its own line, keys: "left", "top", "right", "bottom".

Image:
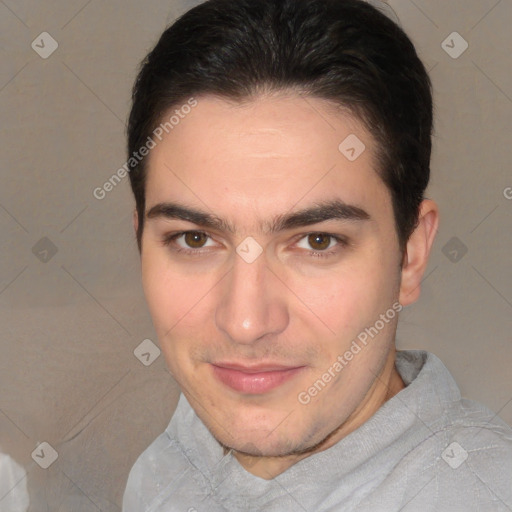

{"left": 123, "top": 350, "right": 512, "bottom": 512}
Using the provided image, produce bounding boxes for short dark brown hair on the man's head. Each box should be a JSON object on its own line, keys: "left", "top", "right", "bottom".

{"left": 128, "top": 0, "right": 433, "bottom": 251}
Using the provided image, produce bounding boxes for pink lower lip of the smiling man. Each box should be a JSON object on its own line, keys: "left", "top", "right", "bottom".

{"left": 212, "top": 365, "right": 304, "bottom": 395}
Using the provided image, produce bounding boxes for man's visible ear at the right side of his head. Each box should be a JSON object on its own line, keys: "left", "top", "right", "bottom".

{"left": 399, "top": 199, "right": 439, "bottom": 306}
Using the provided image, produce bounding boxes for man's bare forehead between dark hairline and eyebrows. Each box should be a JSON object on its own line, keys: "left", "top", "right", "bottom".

{"left": 146, "top": 95, "right": 389, "bottom": 232}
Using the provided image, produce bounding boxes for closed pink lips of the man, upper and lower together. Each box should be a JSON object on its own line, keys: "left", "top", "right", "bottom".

{"left": 212, "top": 363, "right": 304, "bottom": 395}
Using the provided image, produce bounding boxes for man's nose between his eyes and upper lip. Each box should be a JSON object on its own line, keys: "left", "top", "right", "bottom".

{"left": 215, "top": 247, "right": 289, "bottom": 345}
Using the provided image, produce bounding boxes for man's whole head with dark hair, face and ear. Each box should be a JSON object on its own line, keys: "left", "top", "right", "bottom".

{"left": 128, "top": 0, "right": 437, "bottom": 472}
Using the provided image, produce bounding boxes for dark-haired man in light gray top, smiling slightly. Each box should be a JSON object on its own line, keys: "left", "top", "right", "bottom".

{"left": 123, "top": 0, "right": 512, "bottom": 512}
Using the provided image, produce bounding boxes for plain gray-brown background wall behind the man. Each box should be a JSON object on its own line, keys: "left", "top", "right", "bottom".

{"left": 0, "top": 0, "right": 512, "bottom": 512}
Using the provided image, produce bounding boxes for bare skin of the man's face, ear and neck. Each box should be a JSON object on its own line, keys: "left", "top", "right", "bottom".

{"left": 134, "top": 92, "right": 438, "bottom": 479}
